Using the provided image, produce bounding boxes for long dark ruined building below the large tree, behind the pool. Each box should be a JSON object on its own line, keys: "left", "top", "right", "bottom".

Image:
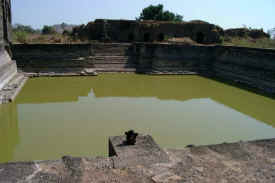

{"left": 73, "top": 19, "right": 224, "bottom": 44}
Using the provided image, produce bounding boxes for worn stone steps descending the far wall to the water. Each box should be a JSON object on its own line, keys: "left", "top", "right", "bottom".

{"left": 90, "top": 43, "right": 136, "bottom": 72}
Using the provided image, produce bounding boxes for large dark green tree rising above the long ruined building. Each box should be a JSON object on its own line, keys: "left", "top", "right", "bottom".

{"left": 137, "top": 4, "right": 183, "bottom": 22}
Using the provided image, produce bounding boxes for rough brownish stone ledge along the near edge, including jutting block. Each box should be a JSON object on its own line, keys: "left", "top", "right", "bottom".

{"left": 0, "top": 135, "right": 275, "bottom": 183}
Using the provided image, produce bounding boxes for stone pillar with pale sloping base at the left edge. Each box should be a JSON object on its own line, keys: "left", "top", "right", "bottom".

{"left": 0, "top": 0, "right": 17, "bottom": 90}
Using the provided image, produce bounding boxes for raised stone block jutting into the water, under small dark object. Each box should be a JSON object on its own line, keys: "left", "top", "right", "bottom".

{"left": 109, "top": 135, "right": 169, "bottom": 168}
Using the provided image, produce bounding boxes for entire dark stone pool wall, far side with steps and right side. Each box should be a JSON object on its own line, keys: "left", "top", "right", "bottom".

{"left": 12, "top": 43, "right": 275, "bottom": 94}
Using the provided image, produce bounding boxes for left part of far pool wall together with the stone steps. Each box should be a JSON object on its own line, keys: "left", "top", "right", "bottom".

{"left": 12, "top": 43, "right": 136, "bottom": 75}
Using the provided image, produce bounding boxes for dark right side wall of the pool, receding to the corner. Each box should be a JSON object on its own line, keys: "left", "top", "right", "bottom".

{"left": 215, "top": 46, "right": 275, "bottom": 94}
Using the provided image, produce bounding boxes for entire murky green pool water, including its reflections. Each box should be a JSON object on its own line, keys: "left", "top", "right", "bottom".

{"left": 0, "top": 74, "right": 275, "bottom": 162}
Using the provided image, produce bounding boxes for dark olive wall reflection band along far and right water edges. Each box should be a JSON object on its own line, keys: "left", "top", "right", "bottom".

{"left": 17, "top": 74, "right": 275, "bottom": 127}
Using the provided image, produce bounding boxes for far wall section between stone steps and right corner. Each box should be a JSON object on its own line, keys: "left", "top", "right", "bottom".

{"left": 136, "top": 44, "right": 213, "bottom": 74}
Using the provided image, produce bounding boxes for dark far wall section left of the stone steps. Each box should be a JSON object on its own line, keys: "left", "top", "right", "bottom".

{"left": 12, "top": 44, "right": 92, "bottom": 72}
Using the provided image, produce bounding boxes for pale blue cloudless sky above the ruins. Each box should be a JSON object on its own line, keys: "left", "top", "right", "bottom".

{"left": 11, "top": 0, "right": 275, "bottom": 30}
